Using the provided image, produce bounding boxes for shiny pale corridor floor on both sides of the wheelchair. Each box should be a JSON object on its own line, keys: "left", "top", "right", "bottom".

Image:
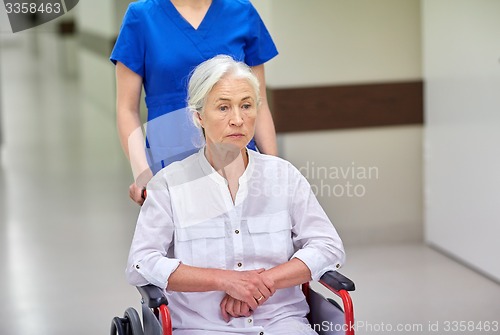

{"left": 0, "top": 38, "right": 500, "bottom": 335}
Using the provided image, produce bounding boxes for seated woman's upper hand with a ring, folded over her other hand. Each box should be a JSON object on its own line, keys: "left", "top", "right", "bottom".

{"left": 221, "top": 269, "right": 276, "bottom": 310}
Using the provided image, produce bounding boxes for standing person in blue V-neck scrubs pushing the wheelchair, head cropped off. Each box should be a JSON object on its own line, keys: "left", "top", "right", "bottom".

{"left": 110, "top": 0, "right": 278, "bottom": 204}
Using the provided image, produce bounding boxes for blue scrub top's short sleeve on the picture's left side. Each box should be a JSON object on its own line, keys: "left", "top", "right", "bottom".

{"left": 109, "top": 3, "right": 145, "bottom": 78}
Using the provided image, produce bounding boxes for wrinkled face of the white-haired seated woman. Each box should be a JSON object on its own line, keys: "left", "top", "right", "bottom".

{"left": 200, "top": 76, "right": 257, "bottom": 149}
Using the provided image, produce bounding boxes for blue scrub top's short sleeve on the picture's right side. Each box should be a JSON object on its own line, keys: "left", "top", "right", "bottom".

{"left": 245, "top": 5, "right": 278, "bottom": 66}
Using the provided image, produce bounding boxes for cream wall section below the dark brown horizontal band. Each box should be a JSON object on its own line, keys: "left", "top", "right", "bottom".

{"left": 282, "top": 126, "right": 422, "bottom": 246}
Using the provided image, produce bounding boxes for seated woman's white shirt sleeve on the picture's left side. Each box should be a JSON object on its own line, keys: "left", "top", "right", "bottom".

{"left": 126, "top": 174, "right": 180, "bottom": 288}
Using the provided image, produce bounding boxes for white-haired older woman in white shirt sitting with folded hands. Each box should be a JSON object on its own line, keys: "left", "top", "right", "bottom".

{"left": 127, "top": 56, "right": 345, "bottom": 335}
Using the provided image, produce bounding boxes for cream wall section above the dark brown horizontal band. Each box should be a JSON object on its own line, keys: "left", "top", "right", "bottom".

{"left": 262, "top": 0, "right": 421, "bottom": 88}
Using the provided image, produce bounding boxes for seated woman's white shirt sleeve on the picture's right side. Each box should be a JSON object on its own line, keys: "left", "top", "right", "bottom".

{"left": 290, "top": 165, "right": 345, "bottom": 280}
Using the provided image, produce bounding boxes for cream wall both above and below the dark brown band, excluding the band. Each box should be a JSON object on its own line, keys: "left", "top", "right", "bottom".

{"left": 252, "top": 0, "right": 423, "bottom": 246}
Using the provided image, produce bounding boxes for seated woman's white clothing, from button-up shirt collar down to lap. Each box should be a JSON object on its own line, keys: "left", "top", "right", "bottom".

{"left": 127, "top": 149, "right": 345, "bottom": 334}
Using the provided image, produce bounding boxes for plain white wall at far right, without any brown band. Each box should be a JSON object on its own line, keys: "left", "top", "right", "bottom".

{"left": 422, "top": 0, "right": 500, "bottom": 281}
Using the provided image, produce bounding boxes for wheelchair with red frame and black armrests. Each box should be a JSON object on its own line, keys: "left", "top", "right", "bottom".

{"left": 110, "top": 271, "right": 355, "bottom": 335}
